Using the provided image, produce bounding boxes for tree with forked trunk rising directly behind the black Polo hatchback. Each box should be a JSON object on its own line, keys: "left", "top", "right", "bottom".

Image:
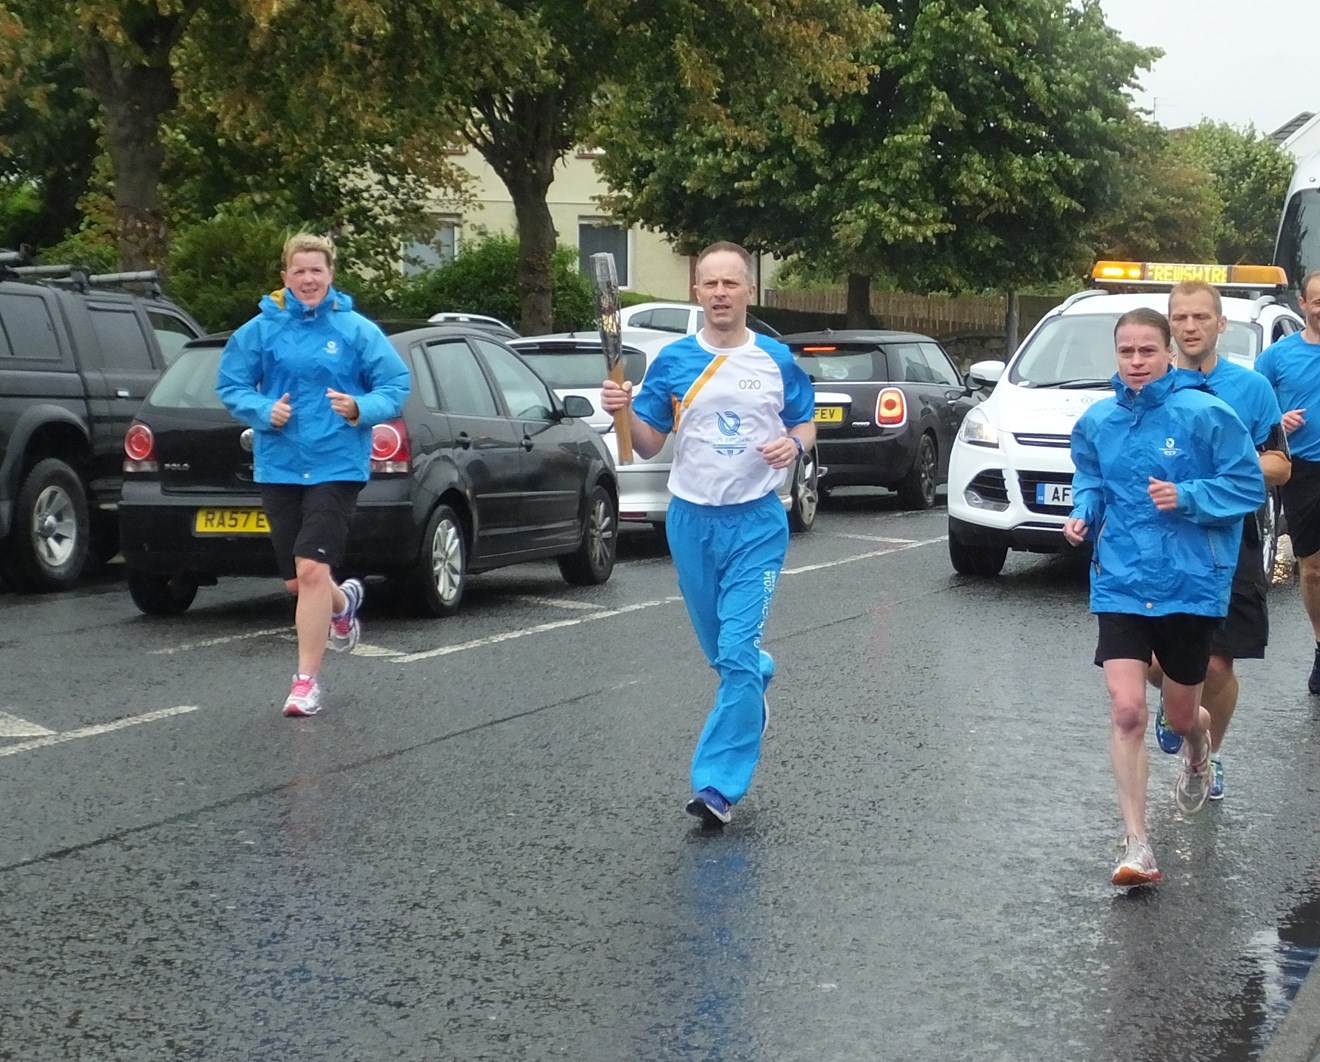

{"left": 200, "top": 0, "right": 875, "bottom": 335}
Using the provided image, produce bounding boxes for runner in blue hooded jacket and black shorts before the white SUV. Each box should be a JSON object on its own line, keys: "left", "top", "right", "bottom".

{"left": 1064, "top": 307, "right": 1265, "bottom": 888}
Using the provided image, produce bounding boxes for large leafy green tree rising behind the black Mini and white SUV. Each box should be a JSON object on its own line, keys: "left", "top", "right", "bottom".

{"left": 599, "top": 0, "right": 1159, "bottom": 325}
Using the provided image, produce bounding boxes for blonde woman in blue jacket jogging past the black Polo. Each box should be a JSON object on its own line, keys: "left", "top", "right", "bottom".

{"left": 216, "top": 232, "right": 408, "bottom": 715}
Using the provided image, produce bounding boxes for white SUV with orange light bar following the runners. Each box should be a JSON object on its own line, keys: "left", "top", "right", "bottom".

{"left": 948, "top": 263, "right": 1303, "bottom": 575}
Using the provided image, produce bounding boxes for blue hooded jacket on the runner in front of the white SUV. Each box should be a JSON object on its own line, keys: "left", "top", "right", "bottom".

{"left": 1071, "top": 368, "right": 1265, "bottom": 616}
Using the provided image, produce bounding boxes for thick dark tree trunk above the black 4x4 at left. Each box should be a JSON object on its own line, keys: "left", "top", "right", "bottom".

{"left": 82, "top": 41, "right": 178, "bottom": 269}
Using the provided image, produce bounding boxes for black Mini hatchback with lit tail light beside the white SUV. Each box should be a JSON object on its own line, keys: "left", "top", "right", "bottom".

{"left": 780, "top": 328, "right": 983, "bottom": 509}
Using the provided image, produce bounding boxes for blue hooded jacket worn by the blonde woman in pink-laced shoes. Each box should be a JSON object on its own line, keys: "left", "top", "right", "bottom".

{"left": 215, "top": 288, "right": 409, "bottom": 487}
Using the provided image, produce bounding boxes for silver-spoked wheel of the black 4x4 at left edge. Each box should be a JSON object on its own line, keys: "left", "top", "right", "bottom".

{"left": 4, "top": 458, "right": 91, "bottom": 592}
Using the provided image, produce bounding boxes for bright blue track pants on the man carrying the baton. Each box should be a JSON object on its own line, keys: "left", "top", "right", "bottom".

{"left": 665, "top": 493, "right": 788, "bottom": 803}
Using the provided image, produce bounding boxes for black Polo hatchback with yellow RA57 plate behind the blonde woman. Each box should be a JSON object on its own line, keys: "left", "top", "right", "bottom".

{"left": 119, "top": 325, "right": 619, "bottom": 616}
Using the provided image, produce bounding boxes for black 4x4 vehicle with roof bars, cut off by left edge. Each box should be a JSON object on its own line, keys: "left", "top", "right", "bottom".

{"left": 0, "top": 252, "right": 203, "bottom": 591}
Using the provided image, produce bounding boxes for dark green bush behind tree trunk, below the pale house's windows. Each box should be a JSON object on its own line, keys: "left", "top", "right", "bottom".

{"left": 372, "top": 235, "right": 595, "bottom": 331}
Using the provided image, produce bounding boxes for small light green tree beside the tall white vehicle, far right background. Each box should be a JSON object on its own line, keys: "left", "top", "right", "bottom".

{"left": 1171, "top": 121, "right": 1295, "bottom": 263}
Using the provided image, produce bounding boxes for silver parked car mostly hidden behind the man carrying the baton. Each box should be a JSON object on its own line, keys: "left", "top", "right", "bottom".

{"left": 510, "top": 328, "right": 825, "bottom": 532}
